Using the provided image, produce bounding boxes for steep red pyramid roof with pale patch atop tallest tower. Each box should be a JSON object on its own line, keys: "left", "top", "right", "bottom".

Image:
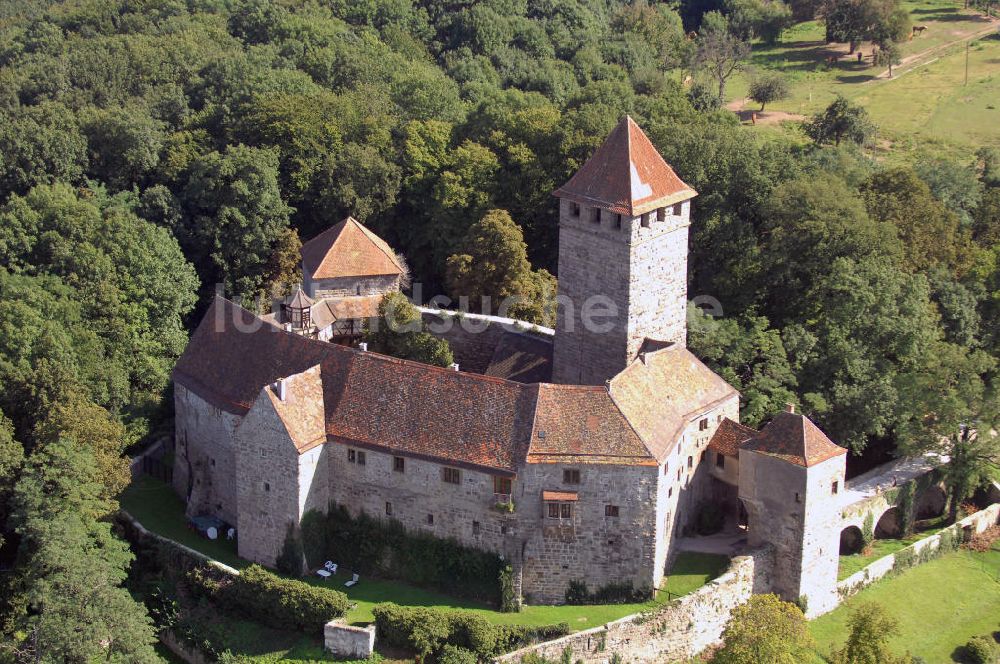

{"left": 554, "top": 115, "right": 698, "bottom": 216}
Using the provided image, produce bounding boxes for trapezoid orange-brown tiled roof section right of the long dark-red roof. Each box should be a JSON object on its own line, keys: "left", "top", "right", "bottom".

{"left": 527, "top": 384, "right": 656, "bottom": 465}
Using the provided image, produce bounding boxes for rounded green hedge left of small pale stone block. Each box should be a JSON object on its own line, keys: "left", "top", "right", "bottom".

{"left": 188, "top": 565, "right": 350, "bottom": 634}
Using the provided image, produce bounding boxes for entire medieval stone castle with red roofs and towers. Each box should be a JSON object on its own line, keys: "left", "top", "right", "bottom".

{"left": 174, "top": 117, "right": 846, "bottom": 615}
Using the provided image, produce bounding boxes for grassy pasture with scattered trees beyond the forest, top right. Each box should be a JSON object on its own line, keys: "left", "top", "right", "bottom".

{"left": 727, "top": 0, "right": 1000, "bottom": 158}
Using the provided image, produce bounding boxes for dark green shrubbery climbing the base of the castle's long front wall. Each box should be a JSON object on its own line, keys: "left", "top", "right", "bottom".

{"left": 300, "top": 504, "right": 504, "bottom": 610}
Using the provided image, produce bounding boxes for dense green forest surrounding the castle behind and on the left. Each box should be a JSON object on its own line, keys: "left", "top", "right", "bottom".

{"left": 0, "top": 0, "right": 1000, "bottom": 662}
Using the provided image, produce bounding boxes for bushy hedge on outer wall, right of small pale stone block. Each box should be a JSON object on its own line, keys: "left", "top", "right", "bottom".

{"left": 372, "top": 602, "right": 570, "bottom": 660}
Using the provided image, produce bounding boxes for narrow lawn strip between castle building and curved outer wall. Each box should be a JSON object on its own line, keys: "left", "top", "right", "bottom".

{"left": 121, "top": 475, "right": 729, "bottom": 631}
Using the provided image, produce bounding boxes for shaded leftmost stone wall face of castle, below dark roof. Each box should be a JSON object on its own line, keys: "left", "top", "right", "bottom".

{"left": 174, "top": 381, "right": 242, "bottom": 524}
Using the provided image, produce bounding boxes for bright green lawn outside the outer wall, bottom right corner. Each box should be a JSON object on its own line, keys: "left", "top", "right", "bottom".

{"left": 810, "top": 542, "right": 1000, "bottom": 664}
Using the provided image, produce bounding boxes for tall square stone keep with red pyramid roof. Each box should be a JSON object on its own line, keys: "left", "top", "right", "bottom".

{"left": 552, "top": 116, "right": 697, "bottom": 385}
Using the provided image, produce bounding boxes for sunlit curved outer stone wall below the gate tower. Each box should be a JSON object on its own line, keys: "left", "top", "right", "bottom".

{"left": 497, "top": 550, "right": 771, "bottom": 664}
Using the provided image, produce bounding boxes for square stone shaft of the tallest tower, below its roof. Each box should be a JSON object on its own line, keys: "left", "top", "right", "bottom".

{"left": 553, "top": 200, "right": 690, "bottom": 385}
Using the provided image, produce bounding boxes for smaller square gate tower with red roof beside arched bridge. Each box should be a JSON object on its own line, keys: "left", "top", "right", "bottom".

{"left": 739, "top": 406, "right": 847, "bottom": 618}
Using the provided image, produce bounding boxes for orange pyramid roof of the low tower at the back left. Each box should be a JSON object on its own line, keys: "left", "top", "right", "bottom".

{"left": 301, "top": 217, "right": 403, "bottom": 279}
